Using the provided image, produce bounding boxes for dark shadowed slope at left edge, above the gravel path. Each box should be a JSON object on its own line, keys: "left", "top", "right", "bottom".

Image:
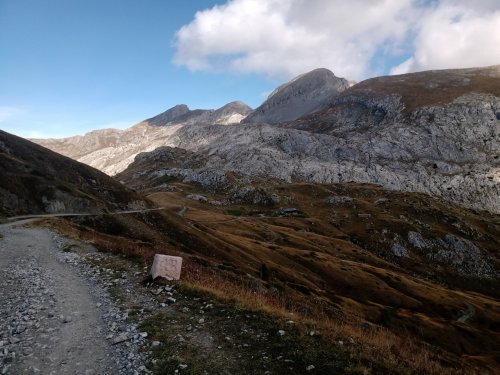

{"left": 0, "top": 131, "right": 151, "bottom": 216}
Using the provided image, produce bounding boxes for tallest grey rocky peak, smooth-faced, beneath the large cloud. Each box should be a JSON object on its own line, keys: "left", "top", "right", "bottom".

{"left": 243, "top": 68, "right": 349, "bottom": 124}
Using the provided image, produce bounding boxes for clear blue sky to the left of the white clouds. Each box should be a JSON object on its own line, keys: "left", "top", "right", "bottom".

{"left": 0, "top": 0, "right": 276, "bottom": 137}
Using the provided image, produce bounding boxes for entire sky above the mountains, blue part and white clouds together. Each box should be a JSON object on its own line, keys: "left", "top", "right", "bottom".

{"left": 0, "top": 0, "right": 500, "bottom": 138}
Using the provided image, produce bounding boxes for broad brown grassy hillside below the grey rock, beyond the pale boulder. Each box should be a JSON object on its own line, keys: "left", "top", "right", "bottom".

{"left": 44, "top": 183, "right": 500, "bottom": 373}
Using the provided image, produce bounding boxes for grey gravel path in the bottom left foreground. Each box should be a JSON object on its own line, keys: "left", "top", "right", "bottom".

{"left": 0, "top": 223, "right": 147, "bottom": 375}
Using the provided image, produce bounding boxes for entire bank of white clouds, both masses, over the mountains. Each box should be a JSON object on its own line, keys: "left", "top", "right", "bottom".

{"left": 174, "top": 0, "right": 500, "bottom": 80}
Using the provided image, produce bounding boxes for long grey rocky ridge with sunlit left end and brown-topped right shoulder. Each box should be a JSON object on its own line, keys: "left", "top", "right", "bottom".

{"left": 33, "top": 66, "right": 500, "bottom": 212}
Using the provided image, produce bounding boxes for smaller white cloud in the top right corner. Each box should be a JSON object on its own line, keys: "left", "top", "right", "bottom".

{"left": 392, "top": 0, "right": 500, "bottom": 74}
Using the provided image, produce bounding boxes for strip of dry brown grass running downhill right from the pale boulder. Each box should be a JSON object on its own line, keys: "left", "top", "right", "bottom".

{"left": 182, "top": 263, "right": 468, "bottom": 374}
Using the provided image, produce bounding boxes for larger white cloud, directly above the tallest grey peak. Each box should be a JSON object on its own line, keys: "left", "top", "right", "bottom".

{"left": 174, "top": 0, "right": 417, "bottom": 79}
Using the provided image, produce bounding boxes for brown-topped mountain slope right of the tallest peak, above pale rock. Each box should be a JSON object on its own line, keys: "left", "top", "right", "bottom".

{"left": 289, "top": 65, "right": 500, "bottom": 133}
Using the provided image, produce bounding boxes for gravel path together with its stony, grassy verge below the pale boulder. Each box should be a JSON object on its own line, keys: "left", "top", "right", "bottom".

{"left": 0, "top": 220, "right": 357, "bottom": 375}
